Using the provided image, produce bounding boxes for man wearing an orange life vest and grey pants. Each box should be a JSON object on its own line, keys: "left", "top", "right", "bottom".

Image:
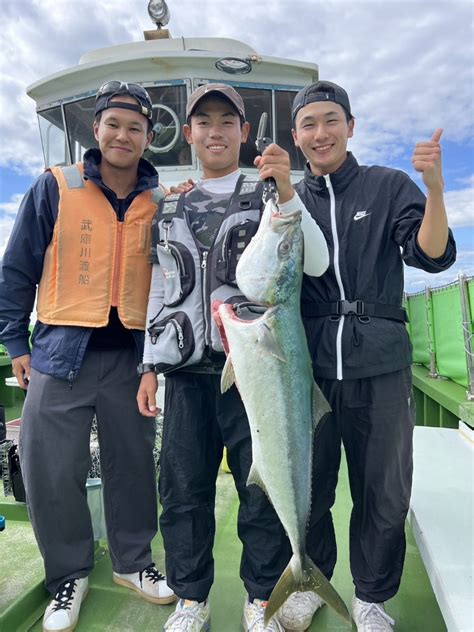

{"left": 0, "top": 81, "right": 175, "bottom": 632}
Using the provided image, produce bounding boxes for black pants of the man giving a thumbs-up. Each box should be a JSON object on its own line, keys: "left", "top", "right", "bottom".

{"left": 307, "top": 368, "right": 414, "bottom": 602}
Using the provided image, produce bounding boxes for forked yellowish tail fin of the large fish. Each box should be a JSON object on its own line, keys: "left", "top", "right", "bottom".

{"left": 264, "top": 554, "right": 351, "bottom": 625}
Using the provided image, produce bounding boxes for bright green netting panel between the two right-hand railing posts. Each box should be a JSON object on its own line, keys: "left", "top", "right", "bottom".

{"left": 431, "top": 284, "right": 468, "bottom": 386}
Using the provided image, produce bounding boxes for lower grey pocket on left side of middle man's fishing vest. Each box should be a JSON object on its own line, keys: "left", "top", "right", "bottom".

{"left": 148, "top": 312, "right": 194, "bottom": 373}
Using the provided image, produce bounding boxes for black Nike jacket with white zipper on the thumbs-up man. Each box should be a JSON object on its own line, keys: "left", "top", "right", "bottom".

{"left": 296, "top": 153, "right": 456, "bottom": 379}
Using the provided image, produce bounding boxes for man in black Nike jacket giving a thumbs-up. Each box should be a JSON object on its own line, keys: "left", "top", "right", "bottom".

{"left": 260, "top": 81, "right": 456, "bottom": 632}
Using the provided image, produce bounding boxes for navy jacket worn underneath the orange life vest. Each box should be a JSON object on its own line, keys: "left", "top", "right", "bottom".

{"left": 0, "top": 149, "right": 158, "bottom": 381}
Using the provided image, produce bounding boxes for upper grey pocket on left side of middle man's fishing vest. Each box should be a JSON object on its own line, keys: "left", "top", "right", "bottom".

{"left": 156, "top": 241, "right": 196, "bottom": 307}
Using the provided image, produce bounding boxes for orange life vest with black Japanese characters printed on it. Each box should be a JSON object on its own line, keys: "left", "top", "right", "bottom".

{"left": 37, "top": 163, "right": 161, "bottom": 330}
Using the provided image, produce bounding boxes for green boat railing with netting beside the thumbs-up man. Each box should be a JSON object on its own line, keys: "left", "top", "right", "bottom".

{"left": 405, "top": 275, "right": 474, "bottom": 427}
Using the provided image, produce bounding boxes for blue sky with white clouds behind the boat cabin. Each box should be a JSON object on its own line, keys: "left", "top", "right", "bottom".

{"left": 0, "top": 0, "right": 474, "bottom": 291}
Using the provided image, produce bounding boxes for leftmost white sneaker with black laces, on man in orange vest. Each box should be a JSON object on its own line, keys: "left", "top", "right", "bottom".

{"left": 43, "top": 577, "right": 89, "bottom": 632}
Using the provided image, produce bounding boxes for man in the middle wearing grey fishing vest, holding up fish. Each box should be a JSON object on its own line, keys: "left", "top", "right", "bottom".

{"left": 138, "top": 83, "right": 328, "bottom": 632}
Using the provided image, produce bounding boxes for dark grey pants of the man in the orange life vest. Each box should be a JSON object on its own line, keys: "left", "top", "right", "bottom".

{"left": 20, "top": 349, "right": 157, "bottom": 594}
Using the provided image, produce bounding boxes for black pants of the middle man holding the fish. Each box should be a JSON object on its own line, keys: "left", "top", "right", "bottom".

{"left": 159, "top": 372, "right": 291, "bottom": 601}
